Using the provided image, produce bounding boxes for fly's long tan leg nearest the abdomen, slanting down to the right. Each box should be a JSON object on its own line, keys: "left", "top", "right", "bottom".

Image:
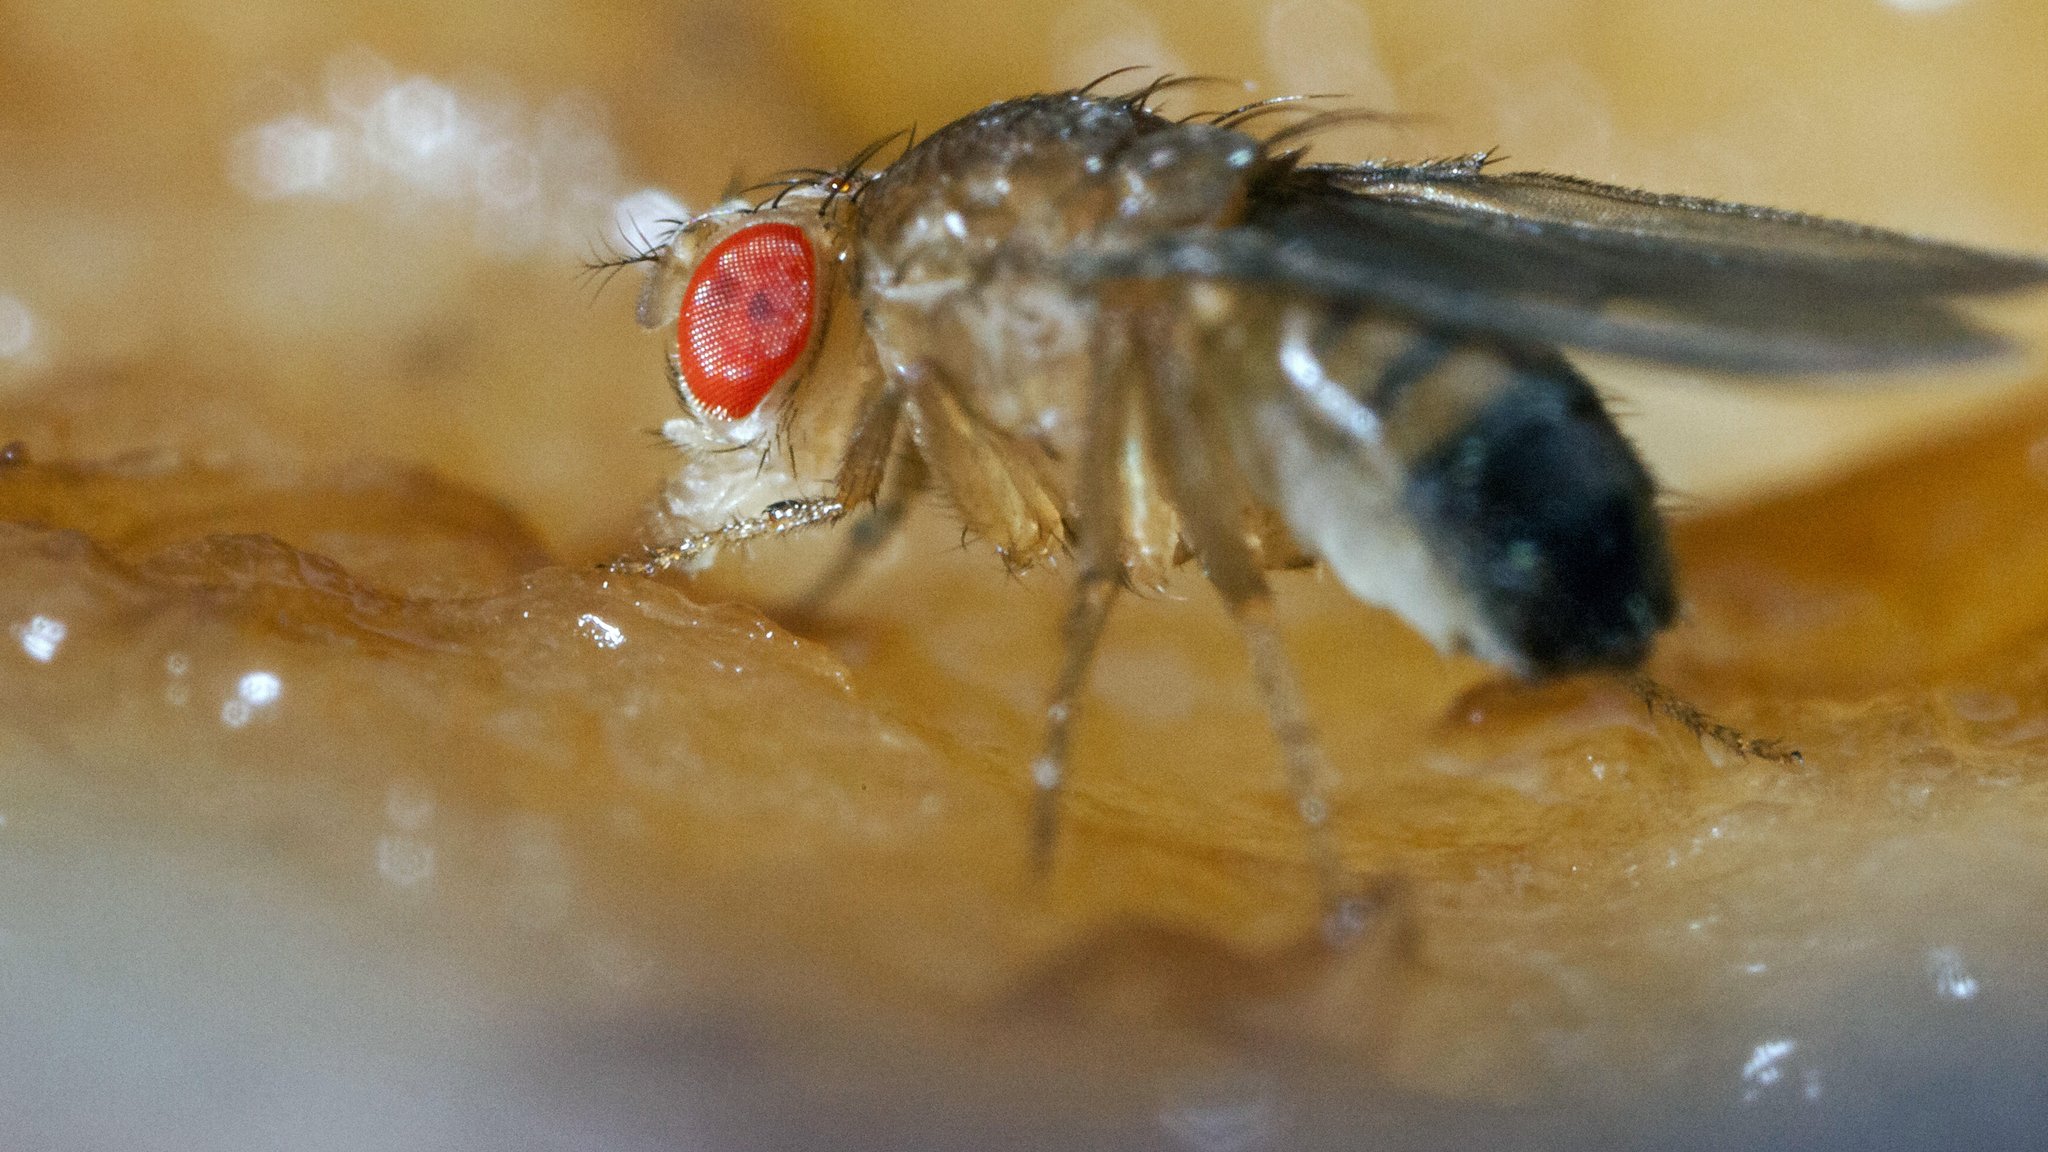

{"left": 1145, "top": 310, "right": 1378, "bottom": 945}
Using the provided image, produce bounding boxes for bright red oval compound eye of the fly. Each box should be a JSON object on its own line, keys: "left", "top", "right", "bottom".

{"left": 676, "top": 223, "right": 817, "bottom": 420}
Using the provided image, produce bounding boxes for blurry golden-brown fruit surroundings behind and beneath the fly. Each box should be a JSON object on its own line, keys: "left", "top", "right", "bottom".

{"left": 0, "top": 0, "right": 2048, "bottom": 1152}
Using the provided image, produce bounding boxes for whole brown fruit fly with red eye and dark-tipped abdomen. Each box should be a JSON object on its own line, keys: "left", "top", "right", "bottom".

{"left": 598, "top": 80, "right": 2048, "bottom": 914}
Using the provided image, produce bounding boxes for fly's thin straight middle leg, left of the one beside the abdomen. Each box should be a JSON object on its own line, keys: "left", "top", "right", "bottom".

{"left": 1030, "top": 336, "right": 1128, "bottom": 877}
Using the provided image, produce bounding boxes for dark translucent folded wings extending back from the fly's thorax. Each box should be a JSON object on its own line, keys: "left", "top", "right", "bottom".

{"left": 1079, "top": 164, "right": 2048, "bottom": 373}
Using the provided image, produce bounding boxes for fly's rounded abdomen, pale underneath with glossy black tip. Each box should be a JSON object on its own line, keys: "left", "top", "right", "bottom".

{"left": 1233, "top": 299, "right": 1675, "bottom": 676}
